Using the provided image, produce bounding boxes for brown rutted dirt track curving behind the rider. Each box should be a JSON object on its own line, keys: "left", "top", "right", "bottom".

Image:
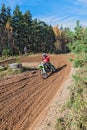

{"left": 0, "top": 55, "right": 70, "bottom": 130}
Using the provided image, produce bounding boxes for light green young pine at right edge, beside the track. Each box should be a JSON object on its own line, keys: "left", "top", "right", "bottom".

{"left": 69, "top": 21, "right": 87, "bottom": 67}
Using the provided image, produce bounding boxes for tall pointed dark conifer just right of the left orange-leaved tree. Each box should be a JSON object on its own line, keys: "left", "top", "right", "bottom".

{"left": 11, "top": 5, "right": 24, "bottom": 53}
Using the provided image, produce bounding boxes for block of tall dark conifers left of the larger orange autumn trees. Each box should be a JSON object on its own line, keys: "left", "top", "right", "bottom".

{"left": 0, "top": 4, "right": 56, "bottom": 55}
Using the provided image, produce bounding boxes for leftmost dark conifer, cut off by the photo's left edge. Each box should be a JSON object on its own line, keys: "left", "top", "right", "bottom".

{"left": 0, "top": 4, "right": 11, "bottom": 54}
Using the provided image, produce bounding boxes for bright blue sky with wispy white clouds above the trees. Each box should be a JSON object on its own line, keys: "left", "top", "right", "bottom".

{"left": 0, "top": 0, "right": 87, "bottom": 29}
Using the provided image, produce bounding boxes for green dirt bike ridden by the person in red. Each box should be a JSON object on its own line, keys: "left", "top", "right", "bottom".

{"left": 38, "top": 62, "right": 56, "bottom": 79}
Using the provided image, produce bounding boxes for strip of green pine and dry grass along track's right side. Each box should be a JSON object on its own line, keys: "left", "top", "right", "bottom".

{"left": 56, "top": 21, "right": 87, "bottom": 130}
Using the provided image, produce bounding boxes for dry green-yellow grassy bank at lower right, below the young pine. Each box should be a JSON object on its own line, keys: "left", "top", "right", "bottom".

{"left": 55, "top": 67, "right": 87, "bottom": 130}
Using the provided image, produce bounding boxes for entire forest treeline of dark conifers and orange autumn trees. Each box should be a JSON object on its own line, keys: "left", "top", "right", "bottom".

{"left": 0, "top": 4, "right": 87, "bottom": 55}
